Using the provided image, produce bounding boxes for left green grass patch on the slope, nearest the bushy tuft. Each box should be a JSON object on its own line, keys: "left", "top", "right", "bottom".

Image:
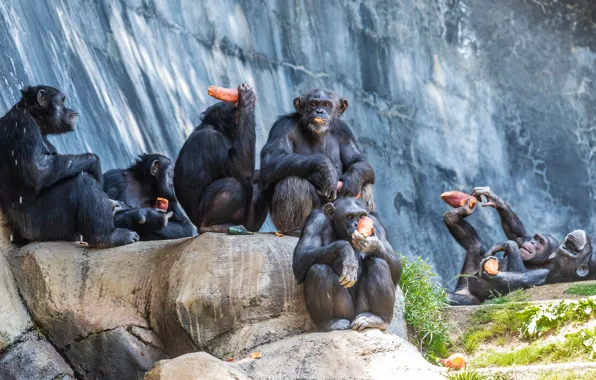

{"left": 462, "top": 303, "right": 528, "bottom": 354}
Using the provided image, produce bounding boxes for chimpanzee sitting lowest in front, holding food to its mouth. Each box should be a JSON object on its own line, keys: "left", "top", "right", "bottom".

{"left": 293, "top": 198, "right": 402, "bottom": 331}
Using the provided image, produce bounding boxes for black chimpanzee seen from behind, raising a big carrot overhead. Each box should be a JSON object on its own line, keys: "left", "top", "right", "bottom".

{"left": 174, "top": 84, "right": 267, "bottom": 232}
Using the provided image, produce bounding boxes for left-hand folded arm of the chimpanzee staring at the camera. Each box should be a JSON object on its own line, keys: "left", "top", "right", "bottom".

{"left": 260, "top": 115, "right": 335, "bottom": 189}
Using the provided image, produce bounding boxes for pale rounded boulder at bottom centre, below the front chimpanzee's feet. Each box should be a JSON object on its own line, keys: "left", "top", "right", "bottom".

{"left": 145, "top": 330, "right": 445, "bottom": 380}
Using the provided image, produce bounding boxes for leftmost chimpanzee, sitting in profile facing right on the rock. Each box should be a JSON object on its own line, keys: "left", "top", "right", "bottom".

{"left": 0, "top": 86, "right": 139, "bottom": 247}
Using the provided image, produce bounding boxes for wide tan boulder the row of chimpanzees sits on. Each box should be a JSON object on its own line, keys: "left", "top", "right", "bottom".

{"left": 11, "top": 234, "right": 405, "bottom": 376}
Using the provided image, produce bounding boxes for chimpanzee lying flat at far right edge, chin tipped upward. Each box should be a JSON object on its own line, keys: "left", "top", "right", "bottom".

{"left": 480, "top": 230, "right": 596, "bottom": 291}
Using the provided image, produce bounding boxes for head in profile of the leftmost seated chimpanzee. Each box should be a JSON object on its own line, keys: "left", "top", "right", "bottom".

{"left": 21, "top": 86, "right": 79, "bottom": 135}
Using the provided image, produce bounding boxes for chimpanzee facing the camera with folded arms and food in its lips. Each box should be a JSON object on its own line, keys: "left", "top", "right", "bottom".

{"left": 261, "top": 89, "right": 375, "bottom": 236}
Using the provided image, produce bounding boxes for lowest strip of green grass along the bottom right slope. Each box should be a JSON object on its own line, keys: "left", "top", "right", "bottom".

{"left": 474, "top": 329, "right": 596, "bottom": 368}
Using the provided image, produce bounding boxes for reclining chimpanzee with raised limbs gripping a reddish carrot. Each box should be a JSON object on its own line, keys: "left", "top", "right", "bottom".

{"left": 443, "top": 187, "right": 558, "bottom": 305}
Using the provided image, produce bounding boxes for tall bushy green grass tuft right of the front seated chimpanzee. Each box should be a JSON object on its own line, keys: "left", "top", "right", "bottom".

{"left": 400, "top": 256, "right": 451, "bottom": 358}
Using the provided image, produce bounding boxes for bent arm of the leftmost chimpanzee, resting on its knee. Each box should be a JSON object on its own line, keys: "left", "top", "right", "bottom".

{"left": 14, "top": 127, "right": 103, "bottom": 192}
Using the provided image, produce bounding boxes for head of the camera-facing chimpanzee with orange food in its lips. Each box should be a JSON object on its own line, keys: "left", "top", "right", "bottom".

{"left": 294, "top": 89, "right": 348, "bottom": 135}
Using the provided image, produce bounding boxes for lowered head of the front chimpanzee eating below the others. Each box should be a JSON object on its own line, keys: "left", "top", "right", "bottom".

{"left": 323, "top": 198, "right": 368, "bottom": 240}
